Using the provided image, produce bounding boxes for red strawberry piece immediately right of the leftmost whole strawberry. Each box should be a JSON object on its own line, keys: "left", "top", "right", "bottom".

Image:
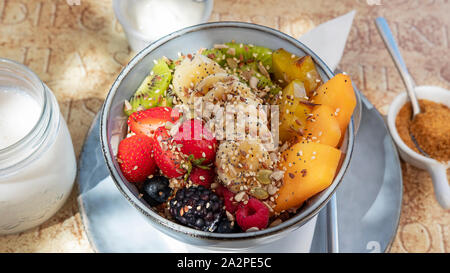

{"left": 153, "top": 127, "right": 187, "bottom": 178}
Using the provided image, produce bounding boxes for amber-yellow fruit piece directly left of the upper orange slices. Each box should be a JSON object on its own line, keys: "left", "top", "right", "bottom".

{"left": 279, "top": 80, "right": 312, "bottom": 142}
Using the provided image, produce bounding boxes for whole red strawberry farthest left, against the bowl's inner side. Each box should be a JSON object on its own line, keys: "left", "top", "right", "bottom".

{"left": 117, "top": 135, "right": 156, "bottom": 183}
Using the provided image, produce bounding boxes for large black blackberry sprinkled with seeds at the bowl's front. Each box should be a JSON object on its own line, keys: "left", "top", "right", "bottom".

{"left": 169, "top": 186, "right": 225, "bottom": 232}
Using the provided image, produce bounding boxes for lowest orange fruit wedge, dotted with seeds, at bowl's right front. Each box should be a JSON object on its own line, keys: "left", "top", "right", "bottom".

{"left": 274, "top": 142, "right": 341, "bottom": 212}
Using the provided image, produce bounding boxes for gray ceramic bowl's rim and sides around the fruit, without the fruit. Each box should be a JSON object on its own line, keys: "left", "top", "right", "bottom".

{"left": 100, "top": 22, "right": 354, "bottom": 249}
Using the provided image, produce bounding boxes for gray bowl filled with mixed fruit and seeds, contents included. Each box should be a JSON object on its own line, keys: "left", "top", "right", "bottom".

{"left": 101, "top": 22, "right": 356, "bottom": 248}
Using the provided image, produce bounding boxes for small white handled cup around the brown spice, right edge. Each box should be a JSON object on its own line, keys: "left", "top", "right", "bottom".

{"left": 387, "top": 86, "right": 450, "bottom": 209}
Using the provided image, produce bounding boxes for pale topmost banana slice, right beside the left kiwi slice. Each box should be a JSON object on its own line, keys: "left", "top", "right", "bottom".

{"left": 172, "top": 54, "right": 225, "bottom": 103}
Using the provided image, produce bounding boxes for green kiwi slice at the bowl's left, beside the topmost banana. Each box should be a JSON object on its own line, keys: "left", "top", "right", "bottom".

{"left": 125, "top": 58, "right": 172, "bottom": 116}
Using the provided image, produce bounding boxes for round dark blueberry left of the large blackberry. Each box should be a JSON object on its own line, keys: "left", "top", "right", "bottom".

{"left": 142, "top": 176, "right": 172, "bottom": 206}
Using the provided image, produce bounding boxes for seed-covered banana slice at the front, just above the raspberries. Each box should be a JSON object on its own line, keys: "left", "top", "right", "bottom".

{"left": 216, "top": 140, "right": 273, "bottom": 193}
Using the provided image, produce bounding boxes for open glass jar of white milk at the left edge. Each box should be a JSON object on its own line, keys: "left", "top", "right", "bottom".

{"left": 0, "top": 58, "right": 76, "bottom": 234}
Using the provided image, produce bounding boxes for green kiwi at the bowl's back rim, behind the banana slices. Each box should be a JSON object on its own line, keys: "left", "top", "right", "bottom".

{"left": 202, "top": 42, "right": 273, "bottom": 70}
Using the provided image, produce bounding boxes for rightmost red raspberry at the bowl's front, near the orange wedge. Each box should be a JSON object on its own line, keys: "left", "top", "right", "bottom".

{"left": 236, "top": 198, "right": 269, "bottom": 231}
